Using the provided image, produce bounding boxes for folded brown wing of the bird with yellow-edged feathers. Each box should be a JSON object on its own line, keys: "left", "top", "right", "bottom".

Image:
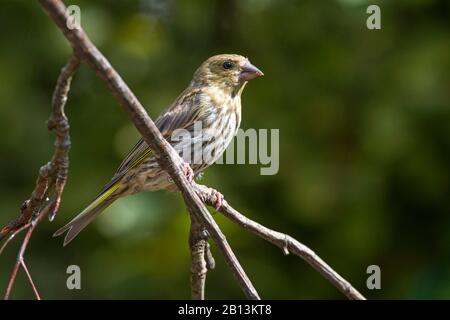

{"left": 100, "top": 88, "right": 202, "bottom": 195}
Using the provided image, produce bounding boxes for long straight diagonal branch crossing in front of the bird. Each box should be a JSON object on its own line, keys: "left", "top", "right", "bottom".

{"left": 39, "top": 0, "right": 260, "bottom": 299}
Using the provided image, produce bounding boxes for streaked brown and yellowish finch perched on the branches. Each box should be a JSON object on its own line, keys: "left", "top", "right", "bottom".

{"left": 54, "top": 54, "right": 264, "bottom": 246}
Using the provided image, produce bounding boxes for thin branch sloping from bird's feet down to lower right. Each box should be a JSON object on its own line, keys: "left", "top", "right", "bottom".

{"left": 194, "top": 185, "right": 365, "bottom": 300}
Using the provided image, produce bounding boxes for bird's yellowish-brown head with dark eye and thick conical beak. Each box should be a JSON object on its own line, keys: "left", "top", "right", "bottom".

{"left": 193, "top": 54, "right": 264, "bottom": 92}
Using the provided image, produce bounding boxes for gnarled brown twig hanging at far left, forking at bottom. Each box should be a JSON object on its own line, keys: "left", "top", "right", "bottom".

{"left": 0, "top": 56, "right": 79, "bottom": 299}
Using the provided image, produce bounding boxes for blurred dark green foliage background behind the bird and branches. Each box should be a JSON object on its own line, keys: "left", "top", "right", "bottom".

{"left": 0, "top": 0, "right": 450, "bottom": 299}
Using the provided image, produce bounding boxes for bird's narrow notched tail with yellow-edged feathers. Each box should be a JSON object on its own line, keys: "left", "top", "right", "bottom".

{"left": 53, "top": 181, "right": 120, "bottom": 246}
